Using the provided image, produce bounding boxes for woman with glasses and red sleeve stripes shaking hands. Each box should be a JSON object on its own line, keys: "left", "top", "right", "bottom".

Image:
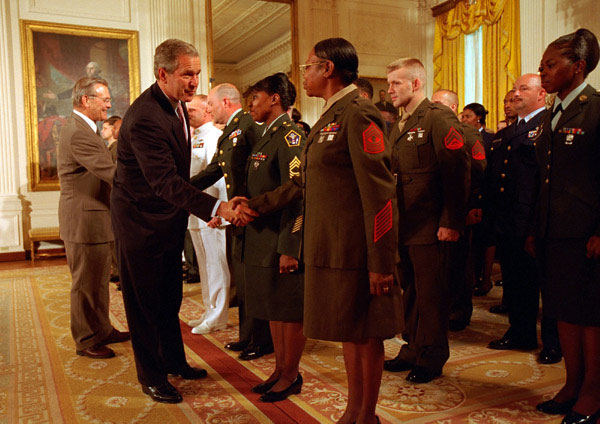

{"left": 234, "top": 38, "right": 403, "bottom": 424}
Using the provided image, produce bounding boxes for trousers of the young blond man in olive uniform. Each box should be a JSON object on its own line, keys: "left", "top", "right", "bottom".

{"left": 398, "top": 243, "right": 450, "bottom": 371}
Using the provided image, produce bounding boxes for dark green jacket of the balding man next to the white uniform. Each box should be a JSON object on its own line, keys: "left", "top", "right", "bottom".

{"left": 190, "top": 111, "right": 257, "bottom": 199}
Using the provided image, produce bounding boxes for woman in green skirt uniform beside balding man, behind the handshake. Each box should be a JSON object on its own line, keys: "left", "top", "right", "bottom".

{"left": 242, "top": 73, "right": 306, "bottom": 402}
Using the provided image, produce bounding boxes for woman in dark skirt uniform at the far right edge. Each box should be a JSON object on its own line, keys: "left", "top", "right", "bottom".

{"left": 536, "top": 29, "right": 600, "bottom": 424}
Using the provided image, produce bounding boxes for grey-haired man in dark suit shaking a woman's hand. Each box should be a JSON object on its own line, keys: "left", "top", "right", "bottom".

{"left": 111, "top": 39, "right": 243, "bottom": 403}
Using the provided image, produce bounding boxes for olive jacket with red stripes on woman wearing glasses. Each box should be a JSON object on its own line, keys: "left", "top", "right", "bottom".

{"left": 249, "top": 90, "right": 398, "bottom": 274}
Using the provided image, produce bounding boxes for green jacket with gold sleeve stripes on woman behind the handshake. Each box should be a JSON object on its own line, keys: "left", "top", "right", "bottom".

{"left": 243, "top": 114, "right": 305, "bottom": 267}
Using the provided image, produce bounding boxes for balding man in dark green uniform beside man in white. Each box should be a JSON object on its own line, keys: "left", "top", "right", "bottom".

{"left": 190, "top": 83, "right": 273, "bottom": 360}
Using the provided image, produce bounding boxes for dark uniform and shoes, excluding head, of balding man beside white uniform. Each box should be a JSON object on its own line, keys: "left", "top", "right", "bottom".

{"left": 190, "top": 108, "right": 272, "bottom": 359}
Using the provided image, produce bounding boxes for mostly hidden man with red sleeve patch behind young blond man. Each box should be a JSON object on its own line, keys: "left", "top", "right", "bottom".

{"left": 431, "top": 90, "right": 487, "bottom": 331}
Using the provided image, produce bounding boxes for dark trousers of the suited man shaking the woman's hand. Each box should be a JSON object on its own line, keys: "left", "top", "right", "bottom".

{"left": 116, "top": 237, "right": 187, "bottom": 386}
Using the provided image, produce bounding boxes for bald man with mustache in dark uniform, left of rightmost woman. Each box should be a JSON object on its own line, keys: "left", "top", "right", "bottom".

{"left": 486, "top": 74, "right": 559, "bottom": 358}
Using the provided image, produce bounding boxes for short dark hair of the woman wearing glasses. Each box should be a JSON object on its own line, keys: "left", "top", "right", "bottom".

{"left": 314, "top": 38, "right": 358, "bottom": 85}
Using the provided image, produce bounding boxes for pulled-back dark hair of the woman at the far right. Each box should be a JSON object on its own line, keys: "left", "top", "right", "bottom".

{"left": 548, "top": 28, "right": 600, "bottom": 77}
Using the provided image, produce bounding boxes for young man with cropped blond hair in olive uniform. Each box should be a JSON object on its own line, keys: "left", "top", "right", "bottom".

{"left": 384, "top": 58, "right": 470, "bottom": 383}
